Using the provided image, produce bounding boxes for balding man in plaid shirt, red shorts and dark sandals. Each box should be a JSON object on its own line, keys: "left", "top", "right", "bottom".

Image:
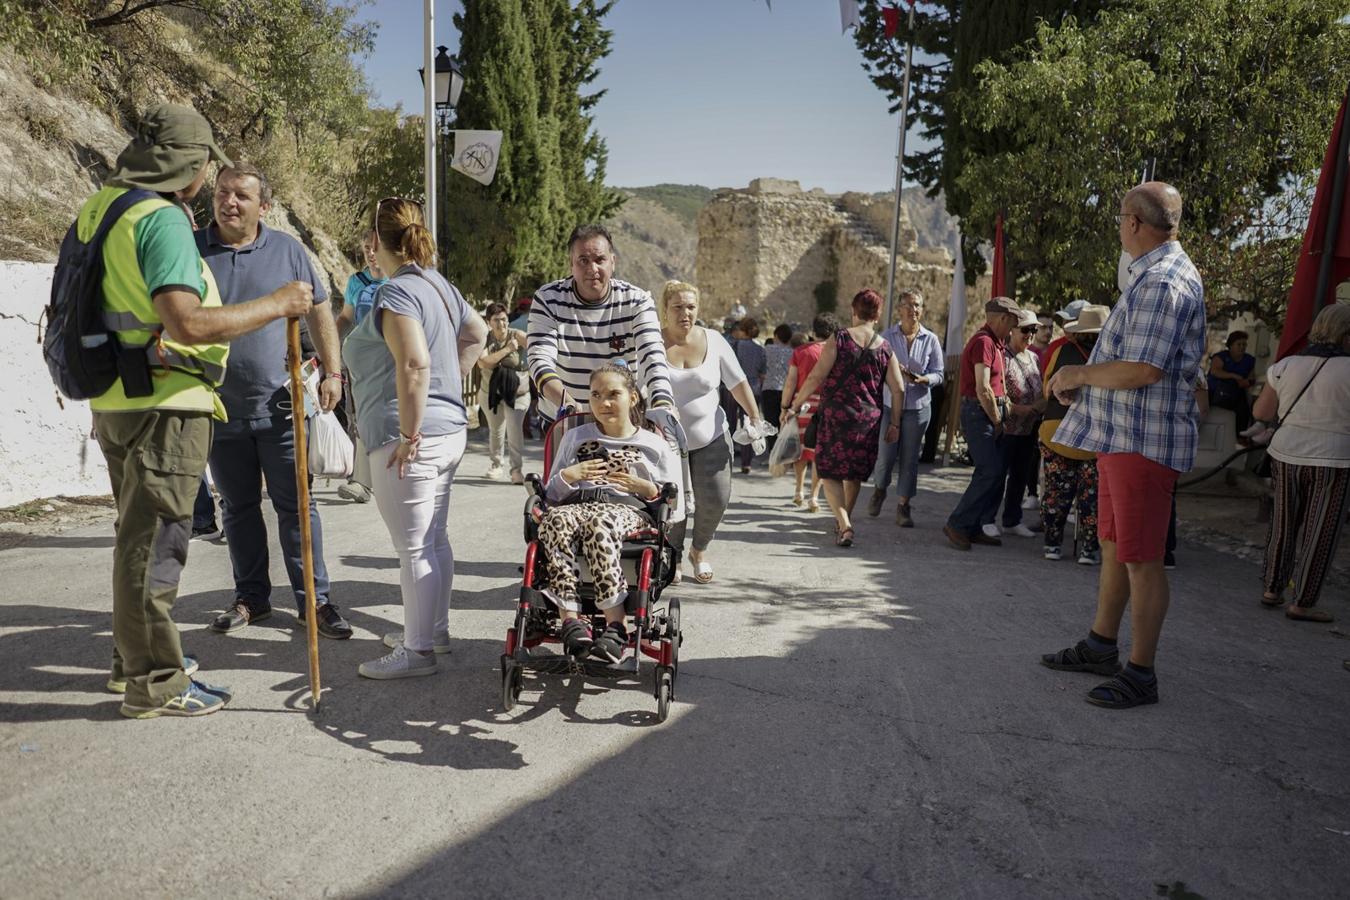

{"left": 1041, "top": 182, "right": 1206, "bottom": 710}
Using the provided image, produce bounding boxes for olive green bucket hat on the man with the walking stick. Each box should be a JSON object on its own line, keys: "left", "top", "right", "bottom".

{"left": 108, "top": 103, "right": 234, "bottom": 193}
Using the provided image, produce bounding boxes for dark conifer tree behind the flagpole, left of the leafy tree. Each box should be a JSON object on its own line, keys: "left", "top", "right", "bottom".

{"left": 855, "top": 0, "right": 1119, "bottom": 282}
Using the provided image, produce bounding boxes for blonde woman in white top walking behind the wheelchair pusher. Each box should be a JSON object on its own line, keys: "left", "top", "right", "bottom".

{"left": 662, "top": 281, "right": 761, "bottom": 584}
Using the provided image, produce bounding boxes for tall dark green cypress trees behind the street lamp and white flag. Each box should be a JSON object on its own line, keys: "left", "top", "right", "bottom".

{"left": 446, "top": 0, "right": 621, "bottom": 300}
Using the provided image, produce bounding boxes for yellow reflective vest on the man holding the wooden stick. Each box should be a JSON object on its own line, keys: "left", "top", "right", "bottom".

{"left": 77, "top": 188, "right": 230, "bottom": 421}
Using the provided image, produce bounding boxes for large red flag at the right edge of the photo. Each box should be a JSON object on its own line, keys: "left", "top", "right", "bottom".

{"left": 1276, "top": 89, "right": 1350, "bottom": 359}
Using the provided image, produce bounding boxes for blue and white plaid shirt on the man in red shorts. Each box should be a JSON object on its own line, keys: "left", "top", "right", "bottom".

{"left": 1054, "top": 240, "right": 1206, "bottom": 472}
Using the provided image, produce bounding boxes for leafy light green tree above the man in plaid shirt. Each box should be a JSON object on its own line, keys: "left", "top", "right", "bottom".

{"left": 957, "top": 0, "right": 1350, "bottom": 325}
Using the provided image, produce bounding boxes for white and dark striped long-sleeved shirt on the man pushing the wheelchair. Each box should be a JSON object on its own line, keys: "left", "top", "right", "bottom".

{"left": 525, "top": 278, "right": 674, "bottom": 412}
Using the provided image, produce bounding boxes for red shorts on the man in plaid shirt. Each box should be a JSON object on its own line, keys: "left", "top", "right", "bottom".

{"left": 1098, "top": 453, "right": 1180, "bottom": 563}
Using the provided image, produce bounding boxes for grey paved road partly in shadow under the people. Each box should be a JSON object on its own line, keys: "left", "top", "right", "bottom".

{"left": 0, "top": 439, "right": 1350, "bottom": 899}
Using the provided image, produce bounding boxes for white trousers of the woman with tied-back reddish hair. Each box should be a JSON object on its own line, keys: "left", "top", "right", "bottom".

{"left": 370, "top": 430, "right": 468, "bottom": 653}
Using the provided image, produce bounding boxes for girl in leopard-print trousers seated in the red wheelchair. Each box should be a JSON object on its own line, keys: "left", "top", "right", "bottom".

{"left": 539, "top": 363, "right": 680, "bottom": 663}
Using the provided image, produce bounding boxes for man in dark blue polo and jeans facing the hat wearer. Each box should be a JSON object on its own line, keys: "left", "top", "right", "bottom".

{"left": 197, "top": 165, "right": 351, "bottom": 640}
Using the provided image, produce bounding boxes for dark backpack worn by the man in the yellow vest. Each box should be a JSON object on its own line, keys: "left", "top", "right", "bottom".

{"left": 42, "top": 189, "right": 158, "bottom": 399}
